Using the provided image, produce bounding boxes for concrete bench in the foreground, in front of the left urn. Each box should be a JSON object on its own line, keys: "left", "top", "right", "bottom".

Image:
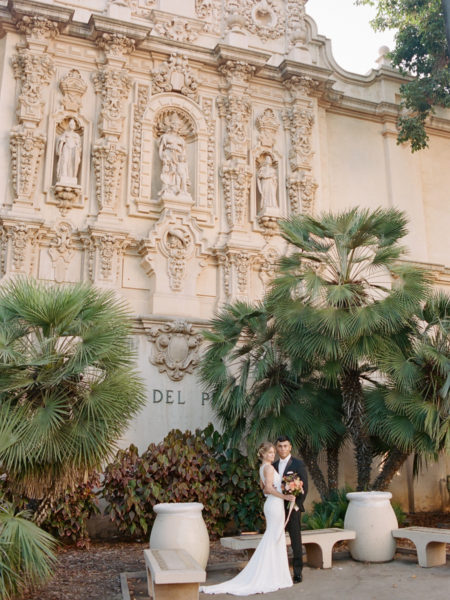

{"left": 144, "top": 549, "right": 206, "bottom": 600}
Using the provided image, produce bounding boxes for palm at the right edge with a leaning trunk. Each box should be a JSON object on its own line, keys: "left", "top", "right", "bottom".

{"left": 368, "top": 292, "right": 450, "bottom": 490}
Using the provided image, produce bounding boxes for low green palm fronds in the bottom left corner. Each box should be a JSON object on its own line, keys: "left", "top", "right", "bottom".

{"left": 0, "top": 503, "right": 56, "bottom": 600}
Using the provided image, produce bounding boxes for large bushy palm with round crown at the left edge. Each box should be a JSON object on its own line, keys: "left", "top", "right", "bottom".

{"left": 0, "top": 279, "right": 144, "bottom": 499}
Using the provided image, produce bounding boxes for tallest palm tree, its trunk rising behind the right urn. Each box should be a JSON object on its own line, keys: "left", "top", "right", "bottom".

{"left": 267, "top": 208, "right": 429, "bottom": 490}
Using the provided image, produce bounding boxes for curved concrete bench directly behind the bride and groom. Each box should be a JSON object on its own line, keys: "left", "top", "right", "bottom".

{"left": 220, "top": 527, "right": 355, "bottom": 569}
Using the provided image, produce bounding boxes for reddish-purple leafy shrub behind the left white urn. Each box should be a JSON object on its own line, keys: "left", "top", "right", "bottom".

{"left": 103, "top": 430, "right": 221, "bottom": 536}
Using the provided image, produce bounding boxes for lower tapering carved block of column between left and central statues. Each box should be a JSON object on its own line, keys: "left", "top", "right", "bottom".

{"left": 92, "top": 138, "right": 126, "bottom": 212}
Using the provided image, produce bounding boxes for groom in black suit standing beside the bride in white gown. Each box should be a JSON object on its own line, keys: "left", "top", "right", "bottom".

{"left": 273, "top": 435, "right": 308, "bottom": 583}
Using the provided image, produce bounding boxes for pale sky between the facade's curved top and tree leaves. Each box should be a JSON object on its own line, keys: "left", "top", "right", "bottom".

{"left": 306, "top": 0, "right": 394, "bottom": 74}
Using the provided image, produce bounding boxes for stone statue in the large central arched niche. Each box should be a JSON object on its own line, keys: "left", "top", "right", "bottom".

{"left": 158, "top": 113, "right": 190, "bottom": 197}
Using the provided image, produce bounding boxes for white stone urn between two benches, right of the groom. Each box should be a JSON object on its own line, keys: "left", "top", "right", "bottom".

{"left": 344, "top": 492, "right": 398, "bottom": 562}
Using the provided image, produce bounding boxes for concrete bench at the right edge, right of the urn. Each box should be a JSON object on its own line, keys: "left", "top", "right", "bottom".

{"left": 392, "top": 527, "right": 450, "bottom": 567}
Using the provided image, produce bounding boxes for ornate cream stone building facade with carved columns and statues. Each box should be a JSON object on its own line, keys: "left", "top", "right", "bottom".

{"left": 0, "top": 0, "right": 450, "bottom": 510}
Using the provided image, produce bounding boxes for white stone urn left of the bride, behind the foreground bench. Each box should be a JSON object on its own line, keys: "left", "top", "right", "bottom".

{"left": 150, "top": 502, "right": 209, "bottom": 568}
